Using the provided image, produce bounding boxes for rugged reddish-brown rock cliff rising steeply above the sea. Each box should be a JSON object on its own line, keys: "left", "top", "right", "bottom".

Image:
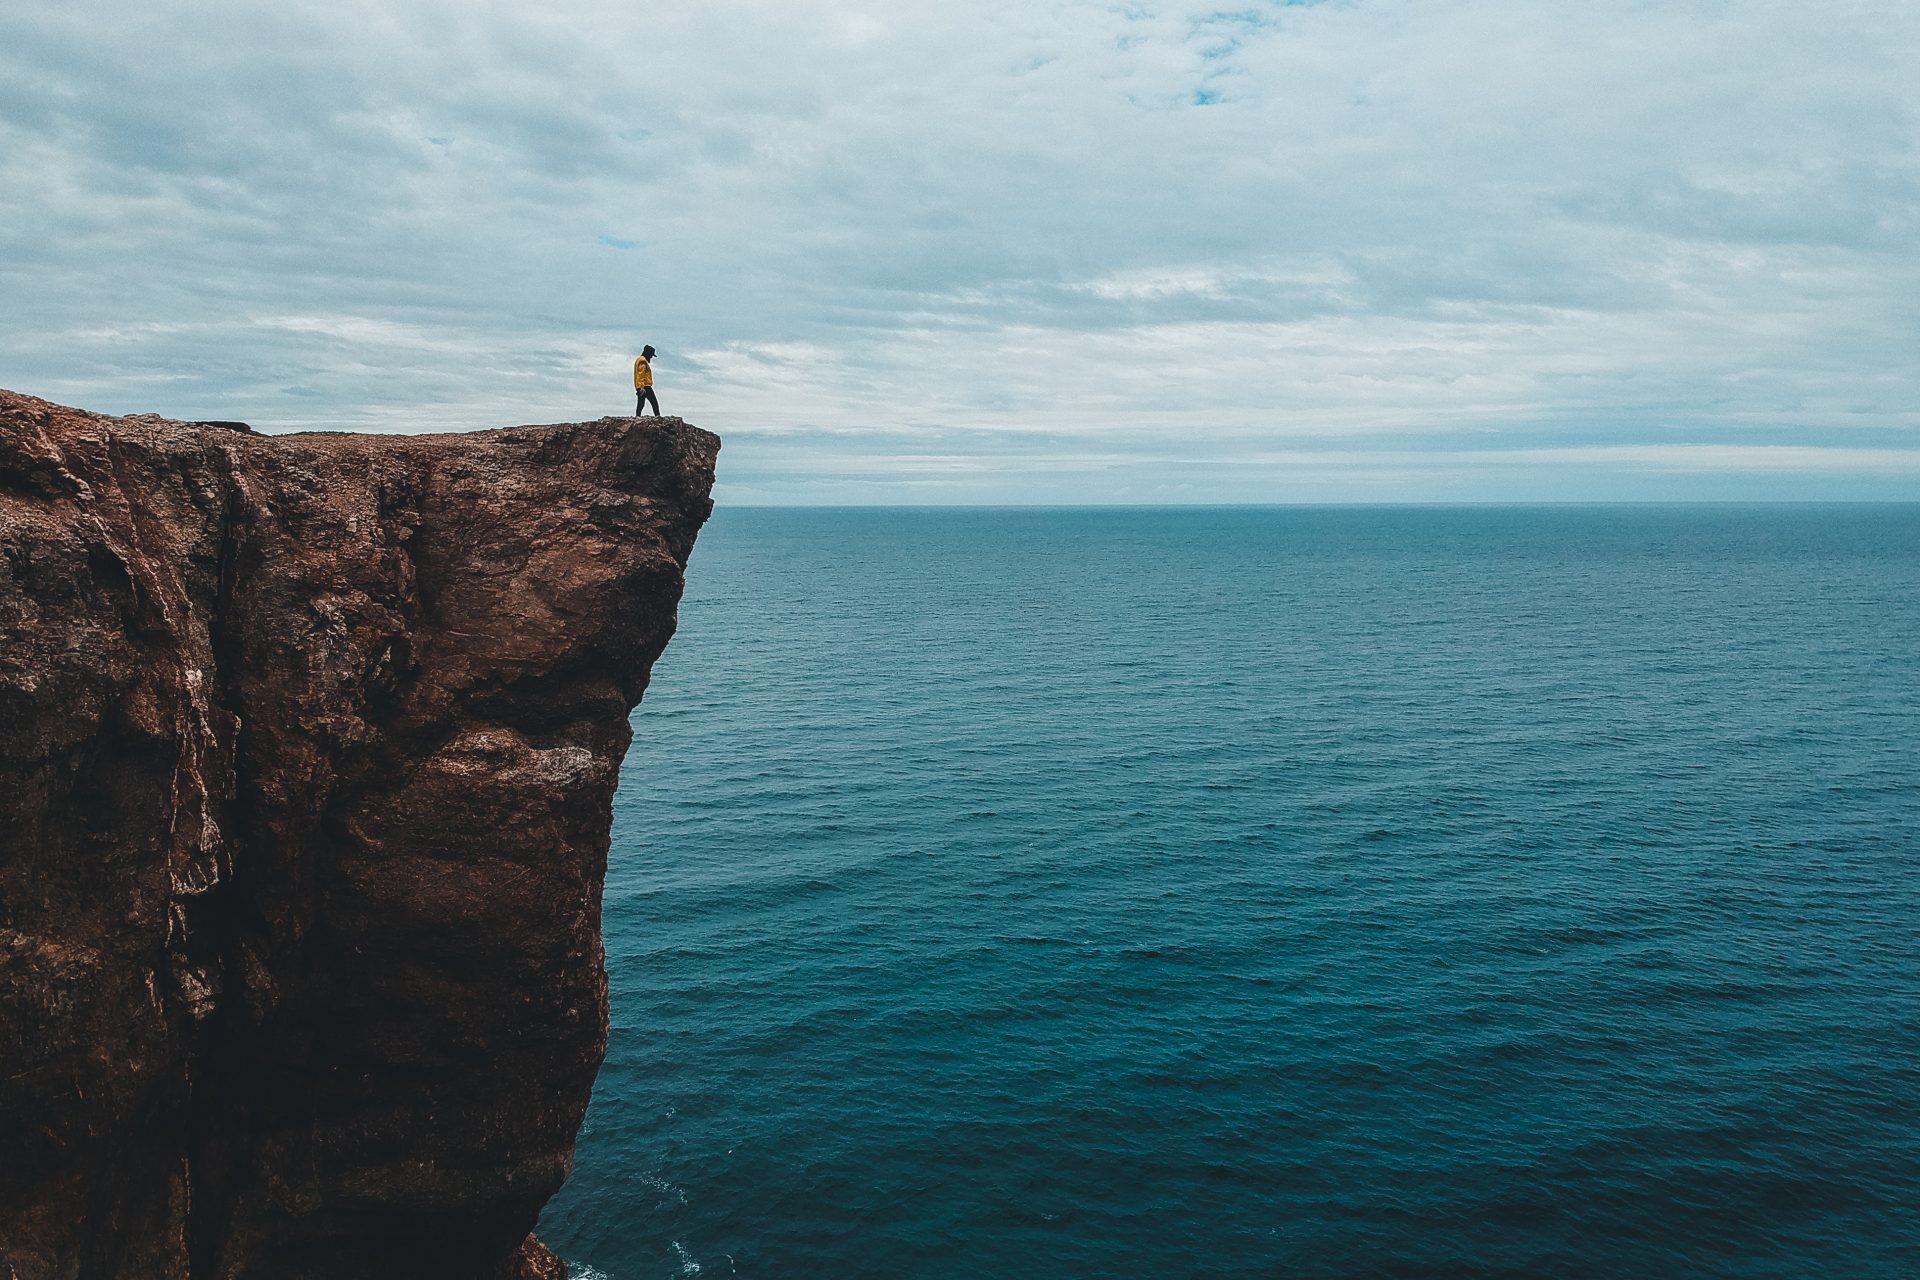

{"left": 0, "top": 393, "right": 718, "bottom": 1280}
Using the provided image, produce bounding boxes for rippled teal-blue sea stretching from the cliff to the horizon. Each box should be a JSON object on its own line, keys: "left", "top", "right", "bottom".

{"left": 541, "top": 507, "right": 1920, "bottom": 1280}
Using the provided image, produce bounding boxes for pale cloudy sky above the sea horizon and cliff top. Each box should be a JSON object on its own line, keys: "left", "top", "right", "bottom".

{"left": 0, "top": 0, "right": 1920, "bottom": 505}
